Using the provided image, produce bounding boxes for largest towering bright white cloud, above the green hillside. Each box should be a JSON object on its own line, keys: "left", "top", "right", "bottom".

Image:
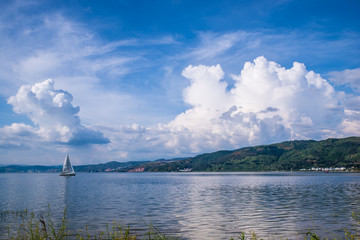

{"left": 161, "top": 57, "right": 344, "bottom": 152}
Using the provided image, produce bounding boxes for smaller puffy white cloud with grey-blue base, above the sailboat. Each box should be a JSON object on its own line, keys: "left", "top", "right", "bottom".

{"left": 0, "top": 79, "right": 109, "bottom": 145}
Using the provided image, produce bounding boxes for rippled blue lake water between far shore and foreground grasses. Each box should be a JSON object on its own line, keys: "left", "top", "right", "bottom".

{"left": 0, "top": 172, "right": 360, "bottom": 239}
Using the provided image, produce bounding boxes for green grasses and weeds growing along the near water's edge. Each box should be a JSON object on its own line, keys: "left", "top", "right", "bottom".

{"left": 0, "top": 209, "right": 360, "bottom": 240}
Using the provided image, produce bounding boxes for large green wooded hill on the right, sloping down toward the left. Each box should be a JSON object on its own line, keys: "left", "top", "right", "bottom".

{"left": 136, "top": 137, "right": 360, "bottom": 172}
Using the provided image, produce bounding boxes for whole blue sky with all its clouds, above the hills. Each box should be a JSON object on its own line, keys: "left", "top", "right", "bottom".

{"left": 0, "top": 0, "right": 360, "bottom": 165}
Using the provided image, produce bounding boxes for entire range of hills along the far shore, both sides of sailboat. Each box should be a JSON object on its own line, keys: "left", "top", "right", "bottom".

{"left": 0, "top": 137, "right": 360, "bottom": 173}
